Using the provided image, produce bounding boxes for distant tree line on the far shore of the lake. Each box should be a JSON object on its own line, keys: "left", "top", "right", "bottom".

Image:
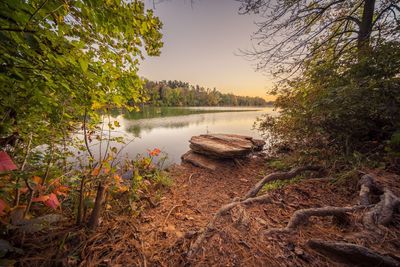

{"left": 145, "top": 81, "right": 268, "bottom": 106}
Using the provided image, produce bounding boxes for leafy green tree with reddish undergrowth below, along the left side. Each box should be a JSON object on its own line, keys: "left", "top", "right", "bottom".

{"left": 0, "top": 0, "right": 162, "bottom": 230}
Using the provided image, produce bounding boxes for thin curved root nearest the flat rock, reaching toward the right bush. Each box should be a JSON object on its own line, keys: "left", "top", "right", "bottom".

{"left": 244, "top": 166, "right": 322, "bottom": 199}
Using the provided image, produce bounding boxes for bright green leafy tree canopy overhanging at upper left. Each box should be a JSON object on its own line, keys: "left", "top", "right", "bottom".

{"left": 0, "top": 0, "right": 162, "bottom": 157}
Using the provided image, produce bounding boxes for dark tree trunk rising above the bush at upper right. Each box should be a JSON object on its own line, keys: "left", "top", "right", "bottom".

{"left": 357, "top": 0, "right": 375, "bottom": 55}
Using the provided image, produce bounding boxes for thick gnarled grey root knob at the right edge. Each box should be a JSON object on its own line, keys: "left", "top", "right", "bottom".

{"left": 363, "top": 188, "right": 400, "bottom": 230}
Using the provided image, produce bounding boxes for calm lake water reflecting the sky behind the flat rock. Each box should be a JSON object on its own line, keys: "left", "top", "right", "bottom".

{"left": 81, "top": 107, "right": 276, "bottom": 168}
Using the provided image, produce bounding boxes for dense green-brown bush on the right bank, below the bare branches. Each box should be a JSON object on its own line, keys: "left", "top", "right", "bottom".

{"left": 258, "top": 42, "right": 400, "bottom": 158}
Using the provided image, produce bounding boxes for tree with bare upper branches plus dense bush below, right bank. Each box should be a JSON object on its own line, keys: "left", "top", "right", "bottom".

{"left": 241, "top": 0, "right": 400, "bottom": 159}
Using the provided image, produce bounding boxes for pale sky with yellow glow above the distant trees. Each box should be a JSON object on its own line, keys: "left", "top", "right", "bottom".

{"left": 139, "top": 0, "right": 272, "bottom": 100}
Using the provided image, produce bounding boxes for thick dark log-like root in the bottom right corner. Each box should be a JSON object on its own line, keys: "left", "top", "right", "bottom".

{"left": 307, "top": 240, "right": 400, "bottom": 267}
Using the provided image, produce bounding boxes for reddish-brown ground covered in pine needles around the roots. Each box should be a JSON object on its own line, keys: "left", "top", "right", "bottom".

{"left": 11, "top": 157, "right": 400, "bottom": 266}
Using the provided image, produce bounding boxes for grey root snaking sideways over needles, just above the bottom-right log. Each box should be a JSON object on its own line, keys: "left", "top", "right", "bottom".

{"left": 267, "top": 206, "right": 364, "bottom": 233}
